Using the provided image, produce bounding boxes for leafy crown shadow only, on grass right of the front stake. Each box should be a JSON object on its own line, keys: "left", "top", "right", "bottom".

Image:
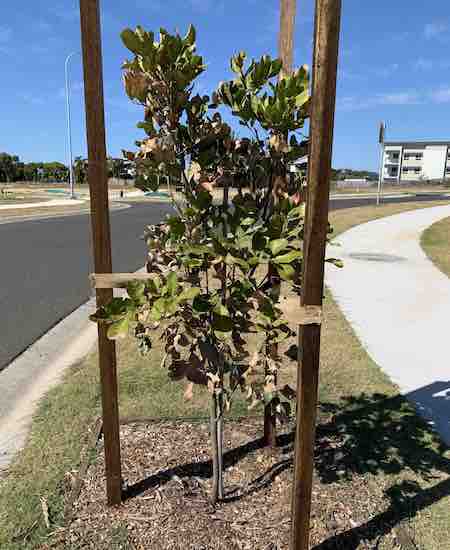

{"left": 315, "top": 394, "right": 450, "bottom": 483}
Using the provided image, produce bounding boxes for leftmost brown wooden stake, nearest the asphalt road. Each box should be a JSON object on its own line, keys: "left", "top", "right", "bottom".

{"left": 80, "top": 0, "right": 122, "bottom": 505}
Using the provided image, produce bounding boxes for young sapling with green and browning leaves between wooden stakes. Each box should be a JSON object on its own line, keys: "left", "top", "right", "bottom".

{"left": 93, "top": 26, "right": 326, "bottom": 502}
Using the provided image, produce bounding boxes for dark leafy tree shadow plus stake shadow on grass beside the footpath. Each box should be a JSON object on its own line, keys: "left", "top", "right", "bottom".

{"left": 314, "top": 390, "right": 450, "bottom": 550}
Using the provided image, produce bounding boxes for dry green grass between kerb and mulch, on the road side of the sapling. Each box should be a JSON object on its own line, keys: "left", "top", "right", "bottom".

{"left": 0, "top": 339, "right": 247, "bottom": 550}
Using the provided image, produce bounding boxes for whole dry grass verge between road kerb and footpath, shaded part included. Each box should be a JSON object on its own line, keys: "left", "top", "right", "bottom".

{"left": 0, "top": 202, "right": 450, "bottom": 550}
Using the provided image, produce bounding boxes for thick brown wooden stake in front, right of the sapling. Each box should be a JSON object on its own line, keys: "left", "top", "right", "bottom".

{"left": 291, "top": 0, "right": 341, "bottom": 550}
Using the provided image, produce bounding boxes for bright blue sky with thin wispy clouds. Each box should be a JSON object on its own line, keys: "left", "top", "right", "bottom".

{"left": 0, "top": 0, "right": 450, "bottom": 169}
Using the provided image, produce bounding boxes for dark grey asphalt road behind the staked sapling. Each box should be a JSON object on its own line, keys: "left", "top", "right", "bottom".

{"left": 0, "top": 195, "right": 449, "bottom": 376}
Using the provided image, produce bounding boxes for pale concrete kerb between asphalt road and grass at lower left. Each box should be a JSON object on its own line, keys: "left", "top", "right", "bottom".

{"left": 0, "top": 269, "right": 143, "bottom": 473}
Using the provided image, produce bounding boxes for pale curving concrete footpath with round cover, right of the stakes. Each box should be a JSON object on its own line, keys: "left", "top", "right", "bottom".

{"left": 326, "top": 205, "right": 450, "bottom": 445}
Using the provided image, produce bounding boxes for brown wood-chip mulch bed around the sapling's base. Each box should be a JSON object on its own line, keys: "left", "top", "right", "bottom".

{"left": 44, "top": 419, "right": 404, "bottom": 550}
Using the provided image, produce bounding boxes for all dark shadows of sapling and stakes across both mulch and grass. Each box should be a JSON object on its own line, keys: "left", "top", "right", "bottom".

{"left": 125, "top": 383, "right": 450, "bottom": 550}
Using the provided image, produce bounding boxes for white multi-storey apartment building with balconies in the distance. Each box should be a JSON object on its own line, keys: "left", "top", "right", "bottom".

{"left": 381, "top": 141, "right": 450, "bottom": 183}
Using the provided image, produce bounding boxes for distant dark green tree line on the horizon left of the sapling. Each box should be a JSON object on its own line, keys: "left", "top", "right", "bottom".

{"left": 0, "top": 153, "right": 132, "bottom": 184}
